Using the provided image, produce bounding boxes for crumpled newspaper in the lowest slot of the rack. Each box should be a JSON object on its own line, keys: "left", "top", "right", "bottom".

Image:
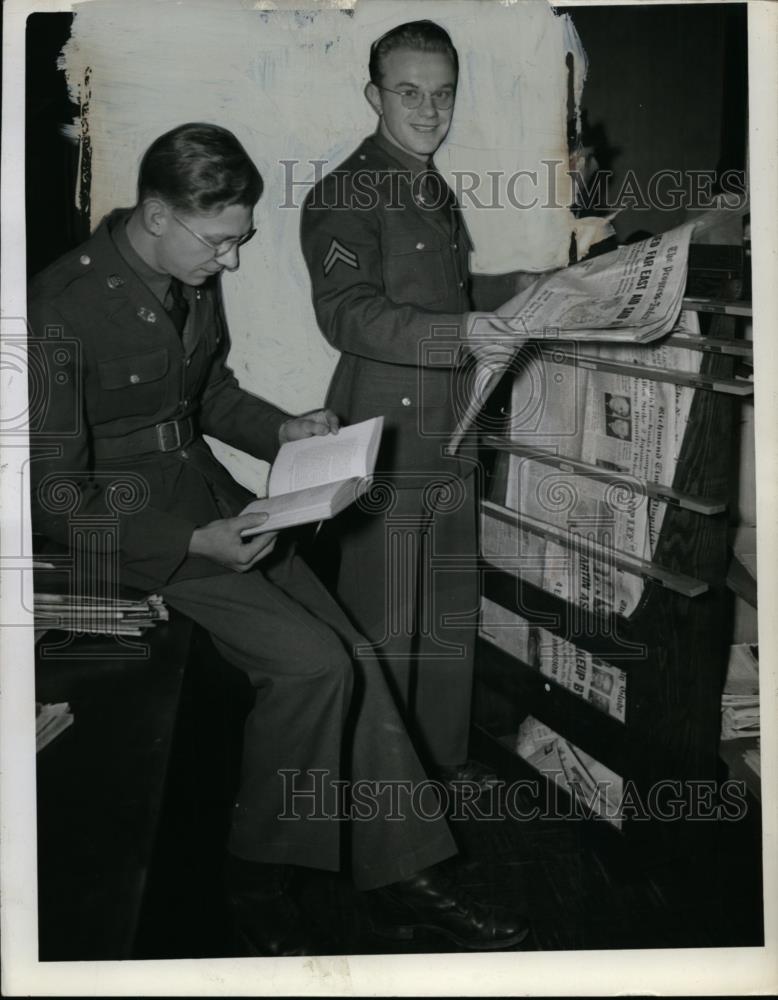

{"left": 515, "top": 715, "right": 624, "bottom": 830}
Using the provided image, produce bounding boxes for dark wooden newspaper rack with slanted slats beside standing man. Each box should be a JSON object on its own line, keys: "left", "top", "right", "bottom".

{"left": 473, "top": 299, "right": 752, "bottom": 850}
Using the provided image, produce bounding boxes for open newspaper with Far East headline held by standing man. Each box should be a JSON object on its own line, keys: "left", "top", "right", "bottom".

{"left": 449, "top": 223, "right": 695, "bottom": 451}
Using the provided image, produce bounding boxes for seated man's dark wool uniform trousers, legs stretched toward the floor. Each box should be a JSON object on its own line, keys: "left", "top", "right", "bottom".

{"left": 162, "top": 539, "right": 456, "bottom": 889}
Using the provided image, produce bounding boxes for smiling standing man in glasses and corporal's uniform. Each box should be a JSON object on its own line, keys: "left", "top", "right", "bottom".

{"left": 301, "top": 21, "right": 516, "bottom": 788}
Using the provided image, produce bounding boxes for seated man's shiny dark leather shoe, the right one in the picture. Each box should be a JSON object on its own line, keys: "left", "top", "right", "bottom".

{"left": 369, "top": 867, "right": 530, "bottom": 951}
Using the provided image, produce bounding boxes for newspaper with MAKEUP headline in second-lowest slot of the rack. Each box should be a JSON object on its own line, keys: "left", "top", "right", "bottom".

{"left": 479, "top": 597, "right": 627, "bottom": 722}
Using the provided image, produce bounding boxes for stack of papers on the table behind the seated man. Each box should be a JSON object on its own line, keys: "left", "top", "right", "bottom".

{"left": 35, "top": 591, "right": 168, "bottom": 636}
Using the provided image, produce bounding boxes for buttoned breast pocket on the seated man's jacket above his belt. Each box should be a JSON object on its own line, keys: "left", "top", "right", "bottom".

{"left": 97, "top": 347, "right": 170, "bottom": 420}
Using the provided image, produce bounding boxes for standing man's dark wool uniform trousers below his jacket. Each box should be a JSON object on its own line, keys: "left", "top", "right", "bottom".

{"left": 327, "top": 473, "right": 479, "bottom": 767}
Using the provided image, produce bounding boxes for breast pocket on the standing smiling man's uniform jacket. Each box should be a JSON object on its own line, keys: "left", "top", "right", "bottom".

{"left": 384, "top": 229, "right": 448, "bottom": 307}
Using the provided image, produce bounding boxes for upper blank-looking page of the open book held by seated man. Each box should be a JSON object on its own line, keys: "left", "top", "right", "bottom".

{"left": 268, "top": 417, "right": 383, "bottom": 497}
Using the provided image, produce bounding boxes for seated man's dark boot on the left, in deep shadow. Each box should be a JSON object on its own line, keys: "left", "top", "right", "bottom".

{"left": 226, "top": 856, "right": 312, "bottom": 958}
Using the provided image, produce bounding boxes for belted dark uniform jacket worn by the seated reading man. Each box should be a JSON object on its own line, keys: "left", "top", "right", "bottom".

{"left": 28, "top": 212, "right": 288, "bottom": 589}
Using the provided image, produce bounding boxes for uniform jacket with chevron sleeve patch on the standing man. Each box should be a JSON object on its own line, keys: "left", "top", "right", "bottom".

{"left": 301, "top": 135, "right": 472, "bottom": 486}
